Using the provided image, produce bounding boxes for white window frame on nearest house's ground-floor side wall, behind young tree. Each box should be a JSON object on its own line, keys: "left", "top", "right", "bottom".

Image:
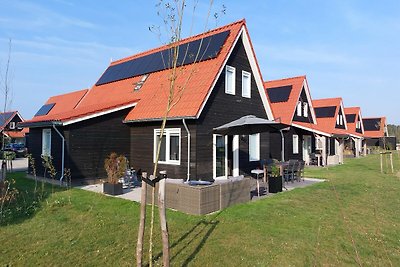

{"left": 153, "top": 128, "right": 182, "bottom": 165}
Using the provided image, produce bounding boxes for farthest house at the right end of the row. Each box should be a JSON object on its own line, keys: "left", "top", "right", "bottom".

{"left": 363, "top": 117, "right": 396, "bottom": 149}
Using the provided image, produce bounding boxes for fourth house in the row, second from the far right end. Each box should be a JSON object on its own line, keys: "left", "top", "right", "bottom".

{"left": 344, "top": 107, "right": 366, "bottom": 157}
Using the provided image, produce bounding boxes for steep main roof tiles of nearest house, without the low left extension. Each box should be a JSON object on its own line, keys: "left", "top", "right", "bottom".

{"left": 122, "top": 20, "right": 245, "bottom": 121}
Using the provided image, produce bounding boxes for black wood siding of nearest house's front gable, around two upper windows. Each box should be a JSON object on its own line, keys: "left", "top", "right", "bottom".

{"left": 196, "top": 40, "right": 269, "bottom": 179}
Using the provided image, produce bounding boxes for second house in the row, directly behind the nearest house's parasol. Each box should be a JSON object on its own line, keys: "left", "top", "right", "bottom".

{"left": 264, "top": 76, "right": 330, "bottom": 165}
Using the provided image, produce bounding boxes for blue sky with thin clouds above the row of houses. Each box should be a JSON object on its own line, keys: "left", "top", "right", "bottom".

{"left": 0, "top": 0, "right": 400, "bottom": 124}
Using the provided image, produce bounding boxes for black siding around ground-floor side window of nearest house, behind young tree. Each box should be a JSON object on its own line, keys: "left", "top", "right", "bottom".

{"left": 129, "top": 120, "right": 196, "bottom": 179}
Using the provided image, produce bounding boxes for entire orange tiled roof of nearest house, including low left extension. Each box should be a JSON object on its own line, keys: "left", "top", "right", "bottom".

{"left": 27, "top": 20, "right": 246, "bottom": 123}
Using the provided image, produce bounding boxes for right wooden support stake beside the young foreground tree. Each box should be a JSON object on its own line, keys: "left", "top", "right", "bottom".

{"left": 158, "top": 179, "right": 169, "bottom": 267}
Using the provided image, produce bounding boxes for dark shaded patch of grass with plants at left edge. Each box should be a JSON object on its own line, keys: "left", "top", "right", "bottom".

{"left": 0, "top": 172, "right": 66, "bottom": 226}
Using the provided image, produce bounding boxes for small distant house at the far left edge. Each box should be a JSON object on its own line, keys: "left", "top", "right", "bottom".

{"left": 0, "top": 111, "right": 28, "bottom": 144}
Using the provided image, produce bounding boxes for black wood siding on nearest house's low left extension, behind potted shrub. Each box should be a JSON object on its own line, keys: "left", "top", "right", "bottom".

{"left": 65, "top": 109, "right": 130, "bottom": 179}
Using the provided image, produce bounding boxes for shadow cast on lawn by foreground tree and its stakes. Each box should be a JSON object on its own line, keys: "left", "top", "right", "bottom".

{"left": 151, "top": 211, "right": 222, "bottom": 266}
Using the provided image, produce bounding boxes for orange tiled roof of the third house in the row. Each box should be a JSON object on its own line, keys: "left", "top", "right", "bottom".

{"left": 313, "top": 97, "right": 348, "bottom": 135}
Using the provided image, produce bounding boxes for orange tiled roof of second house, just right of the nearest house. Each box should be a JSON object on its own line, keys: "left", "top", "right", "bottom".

{"left": 264, "top": 75, "right": 306, "bottom": 125}
